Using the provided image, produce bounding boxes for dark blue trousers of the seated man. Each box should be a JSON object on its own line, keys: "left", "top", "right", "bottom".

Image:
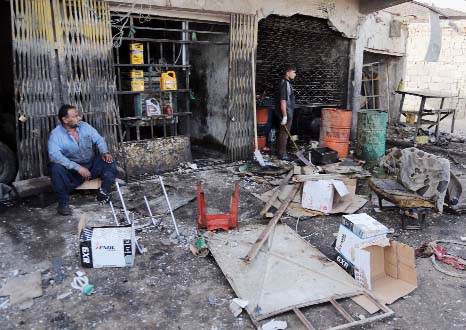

{"left": 49, "top": 157, "right": 117, "bottom": 205}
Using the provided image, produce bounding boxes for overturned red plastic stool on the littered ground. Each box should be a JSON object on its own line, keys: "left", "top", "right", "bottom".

{"left": 197, "top": 182, "right": 239, "bottom": 231}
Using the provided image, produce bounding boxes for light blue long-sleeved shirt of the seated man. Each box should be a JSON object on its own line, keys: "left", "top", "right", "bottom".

{"left": 48, "top": 121, "right": 108, "bottom": 171}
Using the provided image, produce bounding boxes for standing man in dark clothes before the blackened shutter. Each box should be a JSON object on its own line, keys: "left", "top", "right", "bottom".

{"left": 276, "top": 66, "right": 296, "bottom": 160}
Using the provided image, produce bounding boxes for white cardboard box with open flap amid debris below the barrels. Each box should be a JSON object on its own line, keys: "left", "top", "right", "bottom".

{"left": 301, "top": 180, "right": 349, "bottom": 213}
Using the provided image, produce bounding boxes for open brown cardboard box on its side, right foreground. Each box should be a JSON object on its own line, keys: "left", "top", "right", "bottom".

{"left": 354, "top": 240, "right": 417, "bottom": 304}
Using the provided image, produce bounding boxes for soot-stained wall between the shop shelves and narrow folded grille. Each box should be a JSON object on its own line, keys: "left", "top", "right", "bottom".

{"left": 190, "top": 36, "right": 229, "bottom": 144}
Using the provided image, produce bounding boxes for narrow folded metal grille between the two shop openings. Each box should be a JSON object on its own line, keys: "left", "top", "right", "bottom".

{"left": 227, "top": 14, "right": 257, "bottom": 161}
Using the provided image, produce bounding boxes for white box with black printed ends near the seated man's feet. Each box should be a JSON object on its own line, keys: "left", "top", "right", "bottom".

{"left": 79, "top": 225, "right": 136, "bottom": 268}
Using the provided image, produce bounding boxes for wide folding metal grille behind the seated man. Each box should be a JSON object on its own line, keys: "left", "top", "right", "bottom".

{"left": 10, "top": 0, "right": 118, "bottom": 179}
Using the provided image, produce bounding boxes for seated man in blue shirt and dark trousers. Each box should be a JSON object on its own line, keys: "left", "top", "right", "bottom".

{"left": 48, "top": 104, "right": 117, "bottom": 215}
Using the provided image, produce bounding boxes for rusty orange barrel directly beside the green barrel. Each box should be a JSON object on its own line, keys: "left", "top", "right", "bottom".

{"left": 319, "top": 108, "right": 352, "bottom": 158}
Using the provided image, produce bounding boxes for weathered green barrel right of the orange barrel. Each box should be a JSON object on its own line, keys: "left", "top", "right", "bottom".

{"left": 356, "top": 110, "right": 388, "bottom": 161}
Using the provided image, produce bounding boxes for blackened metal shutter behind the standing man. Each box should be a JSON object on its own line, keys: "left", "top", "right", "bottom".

{"left": 256, "top": 15, "right": 350, "bottom": 106}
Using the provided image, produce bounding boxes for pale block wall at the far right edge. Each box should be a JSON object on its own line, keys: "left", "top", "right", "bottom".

{"left": 404, "top": 20, "right": 466, "bottom": 118}
